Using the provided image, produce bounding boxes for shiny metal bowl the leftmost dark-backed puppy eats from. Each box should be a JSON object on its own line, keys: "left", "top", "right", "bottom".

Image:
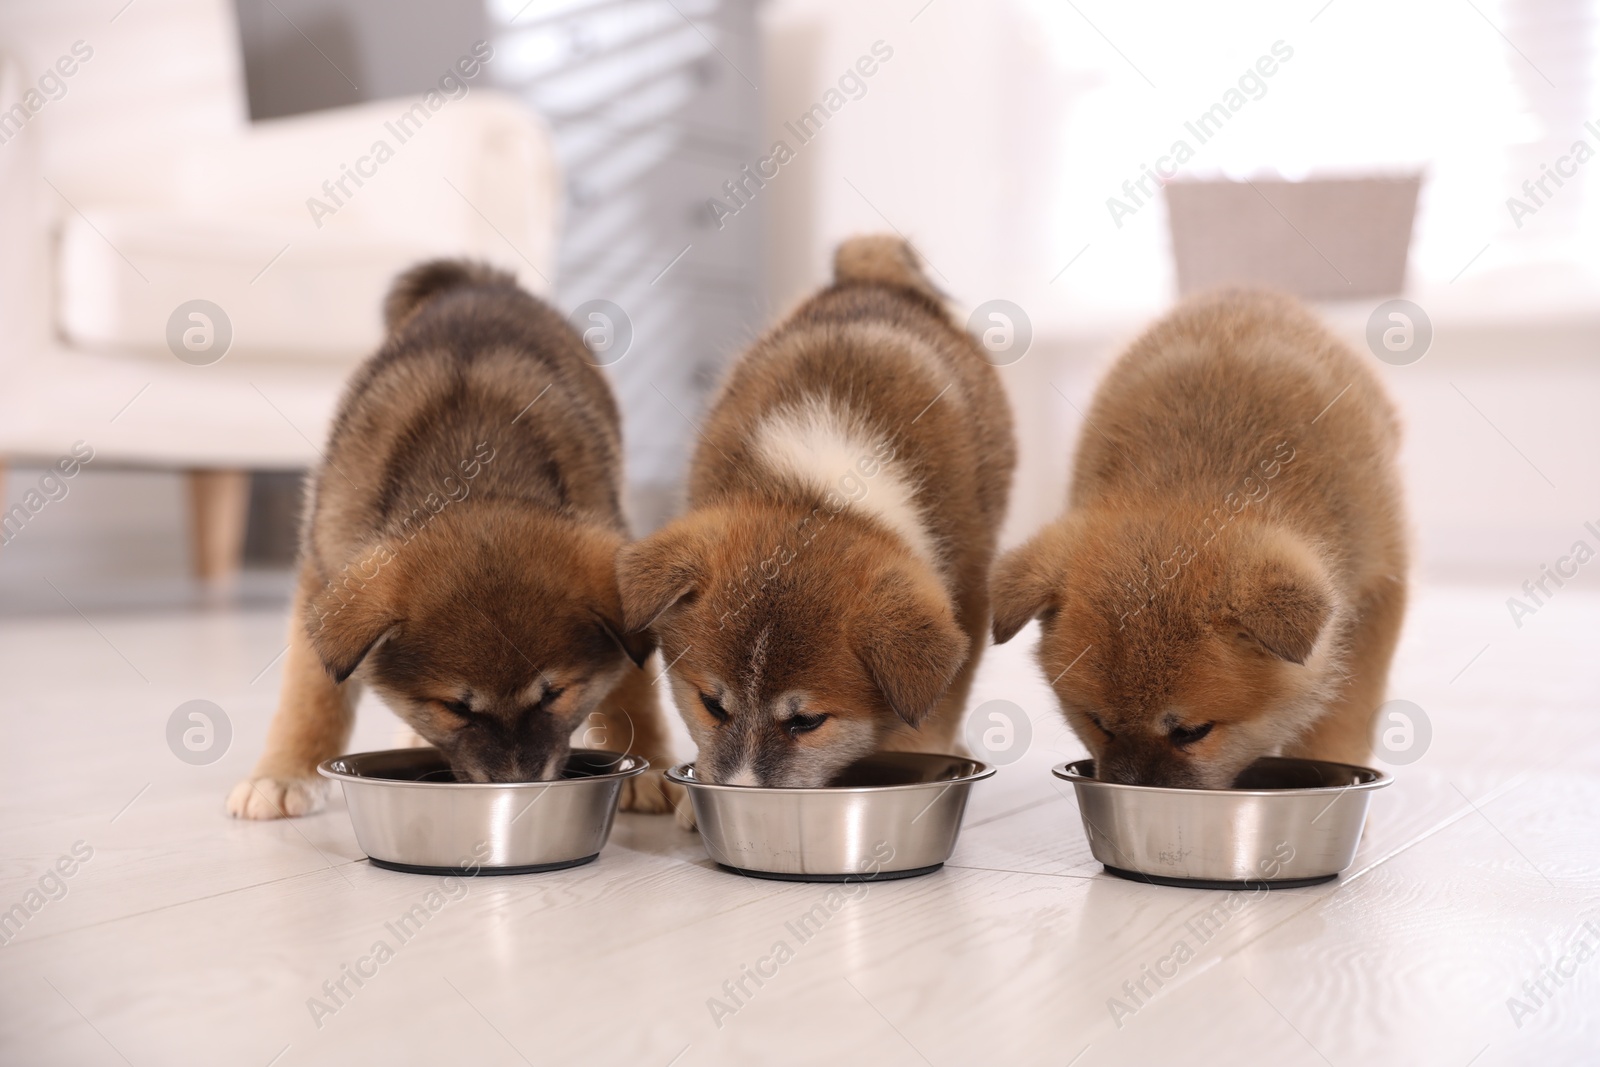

{"left": 317, "top": 749, "right": 650, "bottom": 875}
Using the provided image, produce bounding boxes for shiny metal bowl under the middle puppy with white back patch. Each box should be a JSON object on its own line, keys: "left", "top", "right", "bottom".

{"left": 667, "top": 752, "right": 995, "bottom": 881}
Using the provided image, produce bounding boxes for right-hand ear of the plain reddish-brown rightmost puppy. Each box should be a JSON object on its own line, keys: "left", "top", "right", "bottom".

{"left": 1226, "top": 536, "right": 1336, "bottom": 665}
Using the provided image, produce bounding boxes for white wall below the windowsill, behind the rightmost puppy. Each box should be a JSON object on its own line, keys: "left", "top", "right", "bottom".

{"left": 1000, "top": 318, "right": 1600, "bottom": 595}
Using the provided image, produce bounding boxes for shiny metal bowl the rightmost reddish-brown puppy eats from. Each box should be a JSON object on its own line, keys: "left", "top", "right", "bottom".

{"left": 1054, "top": 757, "right": 1392, "bottom": 889}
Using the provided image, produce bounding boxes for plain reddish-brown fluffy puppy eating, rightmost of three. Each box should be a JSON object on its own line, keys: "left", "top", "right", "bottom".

{"left": 994, "top": 291, "right": 1406, "bottom": 789}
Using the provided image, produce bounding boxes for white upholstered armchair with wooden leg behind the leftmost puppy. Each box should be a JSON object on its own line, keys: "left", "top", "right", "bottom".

{"left": 0, "top": 0, "right": 560, "bottom": 579}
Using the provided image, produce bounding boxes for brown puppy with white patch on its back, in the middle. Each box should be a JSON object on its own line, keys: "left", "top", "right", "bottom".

{"left": 618, "top": 237, "right": 1014, "bottom": 787}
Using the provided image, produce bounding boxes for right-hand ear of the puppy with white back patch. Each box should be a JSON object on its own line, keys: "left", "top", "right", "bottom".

{"left": 853, "top": 576, "right": 971, "bottom": 726}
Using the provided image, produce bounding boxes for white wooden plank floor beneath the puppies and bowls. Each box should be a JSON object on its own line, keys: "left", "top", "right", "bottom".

{"left": 0, "top": 585, "right": 1600, "bottom": 1067}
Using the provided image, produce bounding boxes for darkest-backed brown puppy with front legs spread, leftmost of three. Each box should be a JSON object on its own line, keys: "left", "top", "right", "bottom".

{"left": 227, "top": 261, "right": 670, "bottom": 819}
